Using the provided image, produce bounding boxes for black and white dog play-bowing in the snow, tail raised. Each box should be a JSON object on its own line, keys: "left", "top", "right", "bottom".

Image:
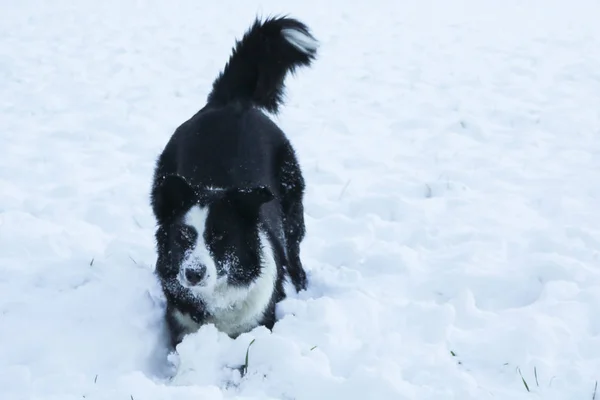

{"left": 151, "top": 17, "right": 318, "bottom": 347}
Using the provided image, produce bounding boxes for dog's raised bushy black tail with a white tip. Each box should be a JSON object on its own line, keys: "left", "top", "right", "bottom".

{"left": 208, "top": 17, "right": 319, "bottom": 114}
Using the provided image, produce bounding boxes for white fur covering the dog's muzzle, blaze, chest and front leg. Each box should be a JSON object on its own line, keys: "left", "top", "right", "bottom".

{"left": 174, "top": 206, "right": 277, "bottom": 335}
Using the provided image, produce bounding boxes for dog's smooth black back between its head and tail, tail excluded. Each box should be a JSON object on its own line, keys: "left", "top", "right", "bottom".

{"left": 159, "top": 104, "right": 288, "bottom": 192}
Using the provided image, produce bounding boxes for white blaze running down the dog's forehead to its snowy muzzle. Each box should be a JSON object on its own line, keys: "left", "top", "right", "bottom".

{"left": 178, "top": 206, "right": 217, "bottom": 293}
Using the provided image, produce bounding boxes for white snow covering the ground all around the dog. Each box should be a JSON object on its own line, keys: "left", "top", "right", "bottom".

{"left": 0, "top": 0, "right": 600, "bottom": 400}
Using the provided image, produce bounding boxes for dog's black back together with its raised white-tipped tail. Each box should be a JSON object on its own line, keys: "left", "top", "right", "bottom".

{"left": 159, "top": 18, "right": 317, "bottom": 195}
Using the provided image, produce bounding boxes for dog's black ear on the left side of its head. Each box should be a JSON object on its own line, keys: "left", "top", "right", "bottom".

{"left": 152, "top": 174, "right": 198, "bottom": 224}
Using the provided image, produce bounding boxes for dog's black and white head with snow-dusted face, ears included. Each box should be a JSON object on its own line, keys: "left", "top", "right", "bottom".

{"left": 153, "top": 175, "right": 273, "bottom": 292}
